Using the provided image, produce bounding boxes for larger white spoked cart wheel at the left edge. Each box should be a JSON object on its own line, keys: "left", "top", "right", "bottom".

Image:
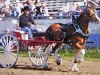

{"left": 0, "top": 34, "right": 19, "bottom": 68}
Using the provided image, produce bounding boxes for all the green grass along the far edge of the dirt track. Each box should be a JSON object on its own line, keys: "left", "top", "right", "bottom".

{"left": 19, "top": 48, "right": 100, "bottom": 60}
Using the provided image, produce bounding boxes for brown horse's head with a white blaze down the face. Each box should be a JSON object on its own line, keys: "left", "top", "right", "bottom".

{"left": 84, "top": 8, "right": 100, "bottom": 23}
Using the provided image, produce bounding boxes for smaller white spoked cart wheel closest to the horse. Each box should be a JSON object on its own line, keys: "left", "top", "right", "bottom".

{"left": 28, "top": 46, "right": 44, "bottom": 67}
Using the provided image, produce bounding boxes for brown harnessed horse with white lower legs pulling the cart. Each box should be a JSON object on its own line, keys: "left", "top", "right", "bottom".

{"left": 46, "top": 7, "right": 100, "bottom": 71}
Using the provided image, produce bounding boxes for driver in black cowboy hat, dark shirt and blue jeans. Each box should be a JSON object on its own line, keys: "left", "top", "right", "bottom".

{"left": 19, "top": 6, "right": 37, "bottom": 39}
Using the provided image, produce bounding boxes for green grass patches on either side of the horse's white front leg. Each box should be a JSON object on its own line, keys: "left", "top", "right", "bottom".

{"left": 59, "top": 48, "right": 100, "bottom": 60}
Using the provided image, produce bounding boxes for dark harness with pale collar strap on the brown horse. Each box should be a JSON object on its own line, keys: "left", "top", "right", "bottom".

{"left": 46, "top": 10, "right": 93, "bottom": 41}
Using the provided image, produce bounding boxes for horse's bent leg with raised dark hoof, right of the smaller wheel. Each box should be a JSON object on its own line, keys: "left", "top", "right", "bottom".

{"left": 53, "top": 43, "right": 62, "bottom": 65}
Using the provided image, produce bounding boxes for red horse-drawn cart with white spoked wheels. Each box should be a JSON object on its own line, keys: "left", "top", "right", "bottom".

{"left": 0, "top": 30, "right": 61, "bottom": 68}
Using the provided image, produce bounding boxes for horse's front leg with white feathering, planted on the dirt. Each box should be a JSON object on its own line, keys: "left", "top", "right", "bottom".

{"left": 72, "top": 49, "right": 85, "bottom": 71}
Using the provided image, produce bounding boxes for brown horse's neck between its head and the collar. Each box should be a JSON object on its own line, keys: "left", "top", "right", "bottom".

{"left": 79, "top": 15, "right": 89, "bottom": 33}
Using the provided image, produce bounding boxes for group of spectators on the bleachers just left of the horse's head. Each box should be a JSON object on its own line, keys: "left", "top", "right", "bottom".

{"left": 59, "top": 2, "right": 100, "bottom": 16}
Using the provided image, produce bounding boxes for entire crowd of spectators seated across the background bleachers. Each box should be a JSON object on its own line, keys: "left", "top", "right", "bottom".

{"left": 0, "top": 0, "right": 100, "bottom": 18}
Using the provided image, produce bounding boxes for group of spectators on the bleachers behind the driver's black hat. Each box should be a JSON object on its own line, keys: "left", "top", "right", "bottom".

{"left": 0, "top": 0, "right": 49, "bottom": 17}
